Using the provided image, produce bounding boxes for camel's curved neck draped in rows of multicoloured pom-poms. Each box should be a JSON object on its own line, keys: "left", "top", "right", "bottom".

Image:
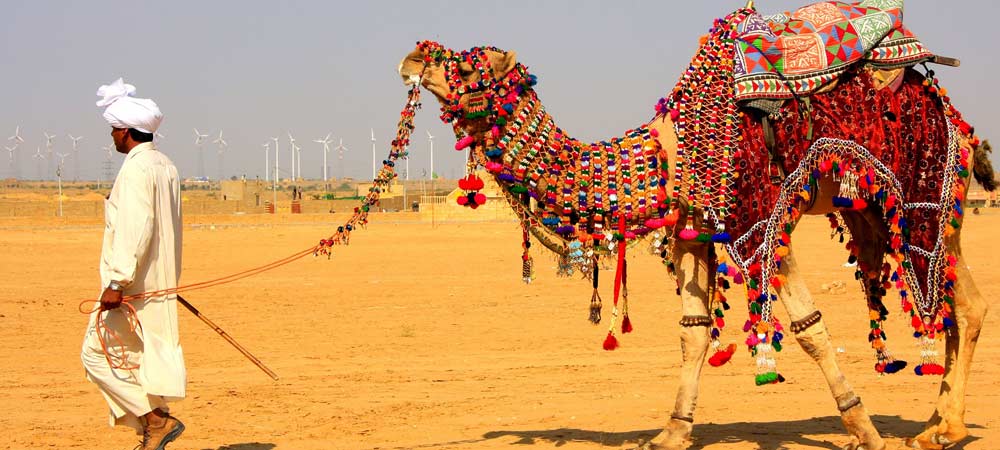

{"left": 478, "top": 90, "right": 667, "bottom": 238}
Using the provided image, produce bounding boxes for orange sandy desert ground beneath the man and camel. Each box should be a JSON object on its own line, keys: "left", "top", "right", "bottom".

{"left": 0, "top": 211, "right": 1000, "bottom": 450}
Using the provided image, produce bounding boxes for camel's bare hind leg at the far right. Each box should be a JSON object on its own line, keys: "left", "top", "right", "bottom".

{"left": 907, "top": 248, "right": 988, "bottom": 450}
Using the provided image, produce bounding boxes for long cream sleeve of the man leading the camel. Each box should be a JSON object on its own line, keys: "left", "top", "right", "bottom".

{"left": 110, "top": 164, "right": 156, "bottom": 285}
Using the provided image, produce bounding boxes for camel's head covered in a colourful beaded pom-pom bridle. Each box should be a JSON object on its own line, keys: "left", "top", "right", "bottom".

{"left": 399, "top": 41, "right": 534, "bottom": 134}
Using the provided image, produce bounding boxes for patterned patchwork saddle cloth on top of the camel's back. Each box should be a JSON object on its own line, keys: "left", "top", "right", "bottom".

{"left": 734, "top": 0, "right": 933, "bottom": 101}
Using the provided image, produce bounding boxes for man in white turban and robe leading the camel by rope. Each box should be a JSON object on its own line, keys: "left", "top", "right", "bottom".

{"left": 81, "top": 78, "right": 187, "bottom": 450}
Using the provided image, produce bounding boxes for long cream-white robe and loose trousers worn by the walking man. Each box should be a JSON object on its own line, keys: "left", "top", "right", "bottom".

{"left": 81, "top": 143, "right": 187, "bottom": 431}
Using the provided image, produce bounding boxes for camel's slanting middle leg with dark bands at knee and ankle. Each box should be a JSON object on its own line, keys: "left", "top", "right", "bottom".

{"left": 779, "top": 246, "right": 885, "bottom": 450}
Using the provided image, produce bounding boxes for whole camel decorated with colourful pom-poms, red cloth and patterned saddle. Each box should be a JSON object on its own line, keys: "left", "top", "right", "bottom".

{"left": 384, "top": 0, "right": 994, "bottom": 450}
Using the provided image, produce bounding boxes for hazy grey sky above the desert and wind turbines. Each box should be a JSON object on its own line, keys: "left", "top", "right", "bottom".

{"left": 0, "top": 0, "right": 1000, "bottom": 179}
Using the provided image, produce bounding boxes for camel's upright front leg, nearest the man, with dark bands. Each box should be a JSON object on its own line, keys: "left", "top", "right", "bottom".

{"left": 640, "top": 242, "right": 715, "bottom": 450}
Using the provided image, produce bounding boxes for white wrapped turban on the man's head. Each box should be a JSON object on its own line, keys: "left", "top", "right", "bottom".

{"left": 97, "top": 78, "right": 163, "bottom": 134}
